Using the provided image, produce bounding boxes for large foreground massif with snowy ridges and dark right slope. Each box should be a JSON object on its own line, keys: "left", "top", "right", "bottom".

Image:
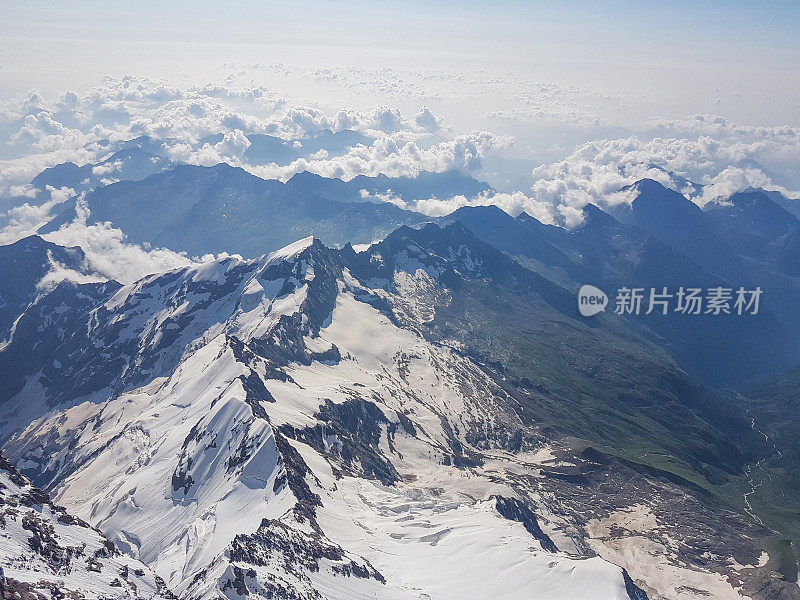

{"left": 0, "top": 224, "right": 800, "bottom": 600}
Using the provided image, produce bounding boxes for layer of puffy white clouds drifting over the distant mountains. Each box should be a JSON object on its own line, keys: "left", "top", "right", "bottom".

{"left": 0, "top": 74, "right": 800, "bottom": 274}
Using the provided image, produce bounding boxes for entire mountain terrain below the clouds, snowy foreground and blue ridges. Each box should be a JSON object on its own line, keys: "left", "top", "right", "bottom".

{"left": 0, "top": 146, "right": 800, "bottom": 600}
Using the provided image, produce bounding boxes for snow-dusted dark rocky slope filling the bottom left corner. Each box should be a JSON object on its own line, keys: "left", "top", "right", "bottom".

{"left": 0, "top": 456, "right": 174, "bottom": 600}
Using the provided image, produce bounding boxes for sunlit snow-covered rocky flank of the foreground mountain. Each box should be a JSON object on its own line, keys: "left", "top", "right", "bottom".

{"left": 0, "top": 234, "right": 636, "bottom": 598}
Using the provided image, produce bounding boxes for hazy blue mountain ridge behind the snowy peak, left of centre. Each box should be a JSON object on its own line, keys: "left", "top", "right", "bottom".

{"left": 44, "top": 164, "right": 434, "bottom": 257}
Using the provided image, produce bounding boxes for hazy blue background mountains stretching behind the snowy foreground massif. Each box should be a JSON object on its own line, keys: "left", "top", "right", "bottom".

{"left": 29, "top": 158, "right": 800, "bottom": 385}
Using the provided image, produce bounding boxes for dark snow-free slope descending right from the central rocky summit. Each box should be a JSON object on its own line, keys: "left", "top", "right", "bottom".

{"left": 351, "top": 224, "right": 768, "bottom": 473}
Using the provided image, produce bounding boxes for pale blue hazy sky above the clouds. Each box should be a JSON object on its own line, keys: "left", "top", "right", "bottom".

{"left": 0, "top": 0, "right": 800, "bottom": 125}
